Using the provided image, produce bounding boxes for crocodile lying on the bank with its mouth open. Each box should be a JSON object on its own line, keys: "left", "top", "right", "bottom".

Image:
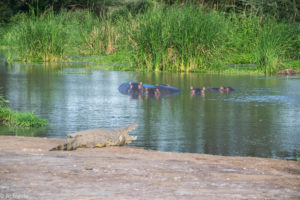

{"left": 50, "top": 123, "right": 138, "bottom": 151}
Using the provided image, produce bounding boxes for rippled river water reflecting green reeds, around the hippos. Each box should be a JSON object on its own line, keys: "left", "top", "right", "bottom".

{"left": 0, "top": 62, "right": 300, "bottom": 159}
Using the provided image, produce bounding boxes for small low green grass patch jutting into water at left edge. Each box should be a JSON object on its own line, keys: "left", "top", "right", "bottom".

{"left": 0, "top": 95, "right": 47, "bottom": 128}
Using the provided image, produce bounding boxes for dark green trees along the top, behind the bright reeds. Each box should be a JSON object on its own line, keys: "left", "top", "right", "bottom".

{"left": 0, "top": 0, "right": 300, "bottom": 23}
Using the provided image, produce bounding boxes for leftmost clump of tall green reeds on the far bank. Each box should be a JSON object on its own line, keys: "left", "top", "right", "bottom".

{"left": 6, "top": 9, "right": 66, "bottom": 61}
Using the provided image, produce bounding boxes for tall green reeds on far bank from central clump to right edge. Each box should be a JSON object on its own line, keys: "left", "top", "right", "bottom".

{"left": 126, "top": 6, "right": 299, "bottom": 73}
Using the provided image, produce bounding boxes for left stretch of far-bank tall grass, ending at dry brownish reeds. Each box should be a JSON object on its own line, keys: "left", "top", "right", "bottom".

{"left": 5, "top": 10, "right": 124, "bottom": 62}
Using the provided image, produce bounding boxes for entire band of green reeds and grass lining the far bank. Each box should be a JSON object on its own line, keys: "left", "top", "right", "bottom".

{"left": 0, "top": 0, "right": 300, "bottom": 74}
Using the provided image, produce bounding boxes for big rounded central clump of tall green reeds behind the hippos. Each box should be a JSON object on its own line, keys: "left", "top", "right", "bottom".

{"left": 128, "top": 6, "right": 227, "bottom": 71}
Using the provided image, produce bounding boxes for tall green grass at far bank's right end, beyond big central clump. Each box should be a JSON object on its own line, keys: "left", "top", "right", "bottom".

{"left": 226, "top": 13, "right": 300, "bottom": 73}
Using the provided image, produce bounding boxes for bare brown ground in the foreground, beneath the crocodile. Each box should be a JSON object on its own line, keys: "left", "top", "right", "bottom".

{"left": 0, "top": 136, "right": 300, "bottom": 200}
